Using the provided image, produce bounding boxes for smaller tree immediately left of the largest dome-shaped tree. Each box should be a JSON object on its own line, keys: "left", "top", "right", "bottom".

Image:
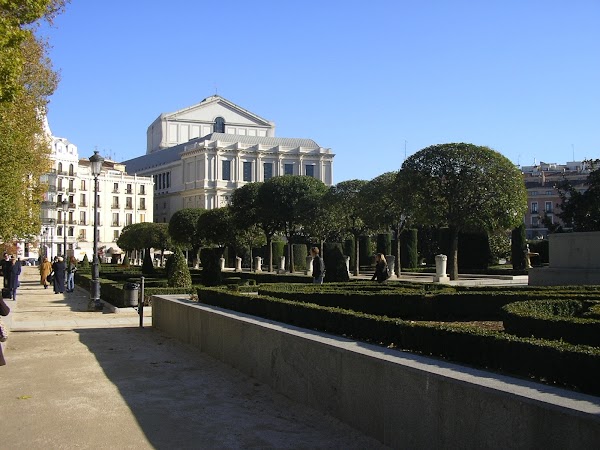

{"left": 359, "top": 172, "right": 409, "bottom": 275}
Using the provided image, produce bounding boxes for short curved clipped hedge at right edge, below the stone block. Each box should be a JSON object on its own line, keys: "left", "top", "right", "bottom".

{"left": 503, "top": 299, "right": 600, "bottom": 347}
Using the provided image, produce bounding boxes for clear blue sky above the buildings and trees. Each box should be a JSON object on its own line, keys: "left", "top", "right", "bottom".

{"left": 42, "top": 0, "right": 600, "bottom": 183}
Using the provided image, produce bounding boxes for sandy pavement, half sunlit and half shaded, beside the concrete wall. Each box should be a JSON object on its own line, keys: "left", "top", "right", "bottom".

{"left": 0, "top": 267, "right": 384, "bottom": 450}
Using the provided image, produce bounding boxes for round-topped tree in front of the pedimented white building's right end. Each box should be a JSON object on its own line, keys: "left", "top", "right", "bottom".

{"left": 258, "top": 175, "right": 327, "bottom": 272}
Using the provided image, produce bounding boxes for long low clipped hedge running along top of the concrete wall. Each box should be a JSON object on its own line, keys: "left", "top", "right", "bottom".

{"left": 198, "top": 288, "right": 600, "bottom": 395}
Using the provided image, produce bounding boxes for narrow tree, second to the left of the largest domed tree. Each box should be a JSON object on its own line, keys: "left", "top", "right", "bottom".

{"left": 324, "top": 180, "right": 368, "bottom": 276}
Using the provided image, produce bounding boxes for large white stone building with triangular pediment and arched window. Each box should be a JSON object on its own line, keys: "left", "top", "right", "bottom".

{"left": 123, "top": 95, "right": 334, "bottom": 222}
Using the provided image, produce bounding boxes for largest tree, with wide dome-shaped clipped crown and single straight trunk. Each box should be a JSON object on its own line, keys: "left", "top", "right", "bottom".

{"left": 399, "top": 143, "right": 527, "bottom": 280}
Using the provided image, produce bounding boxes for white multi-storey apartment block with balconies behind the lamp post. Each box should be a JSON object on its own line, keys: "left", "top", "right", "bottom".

{"left": 39, "top": 128, "right": 154, "bottom": 261}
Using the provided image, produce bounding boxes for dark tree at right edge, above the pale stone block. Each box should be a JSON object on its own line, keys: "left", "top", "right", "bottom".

{"left": 556, "top": 159, "right": 600, "bottom": 231}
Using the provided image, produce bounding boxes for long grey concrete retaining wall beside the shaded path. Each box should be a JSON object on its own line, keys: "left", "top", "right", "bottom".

{"left": 152, "top": 296, "right": 600, "bottom": 449}
